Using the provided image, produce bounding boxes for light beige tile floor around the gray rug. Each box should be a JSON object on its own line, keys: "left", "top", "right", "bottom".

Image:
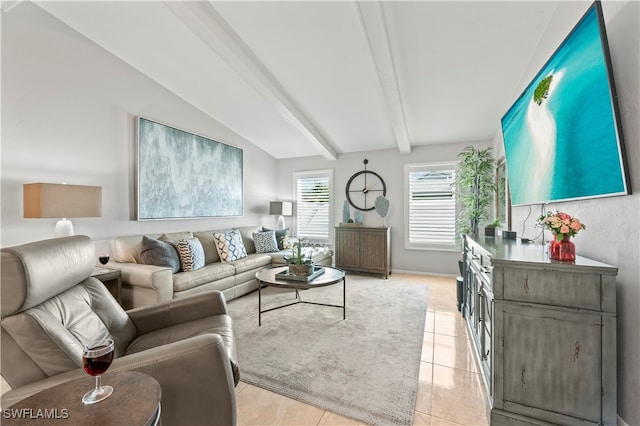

{"left": 236, "top": 274, "right": 489, "bottom": 426}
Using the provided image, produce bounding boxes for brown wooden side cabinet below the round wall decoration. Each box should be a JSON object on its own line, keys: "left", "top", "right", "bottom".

{"left": 335, "top": 226, "right": 391, "bottom": 278}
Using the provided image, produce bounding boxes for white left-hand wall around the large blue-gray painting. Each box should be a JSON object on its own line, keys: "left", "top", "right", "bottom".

{"left": 0, "top": 2, "right": 277, "bottom": 247}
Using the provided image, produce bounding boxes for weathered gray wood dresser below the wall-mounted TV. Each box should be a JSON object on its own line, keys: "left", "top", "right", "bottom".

{"left": 462, "top": 236, "right": 618, "bottom": 425}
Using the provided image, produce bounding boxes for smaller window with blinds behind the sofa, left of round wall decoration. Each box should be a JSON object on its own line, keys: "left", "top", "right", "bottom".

{"left": 293, "top": 170, "right": 333, "bottom": 242}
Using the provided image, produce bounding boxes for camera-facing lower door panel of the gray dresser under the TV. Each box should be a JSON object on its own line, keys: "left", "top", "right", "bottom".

{"left": 502, "top": 304, "right": 602, "bottom": 424}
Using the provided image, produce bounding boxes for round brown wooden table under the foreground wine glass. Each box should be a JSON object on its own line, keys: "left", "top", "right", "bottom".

{"left": 2, "top": 371, "right": 162, "bottom": 426}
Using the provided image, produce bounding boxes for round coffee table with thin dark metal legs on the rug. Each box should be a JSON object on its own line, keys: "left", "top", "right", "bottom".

{"left": 256, "top": 266, "right": 347, "bottom": 326}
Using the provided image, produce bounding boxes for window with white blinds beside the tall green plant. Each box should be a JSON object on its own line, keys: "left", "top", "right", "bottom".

{"left": 405, "top": 162, "right": 456, "bottom": 250}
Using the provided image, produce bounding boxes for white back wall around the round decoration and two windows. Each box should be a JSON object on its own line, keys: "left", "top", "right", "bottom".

{"left": 278, "top": 141, "right": 491, "bottom": 275}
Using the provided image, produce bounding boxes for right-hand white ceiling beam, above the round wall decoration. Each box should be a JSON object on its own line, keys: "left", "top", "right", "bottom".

{"left": 356, "top": 1, "right": 411, "bottom": 154}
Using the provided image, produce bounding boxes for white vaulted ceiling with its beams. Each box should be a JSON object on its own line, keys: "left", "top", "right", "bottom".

{"left": 28, "top": 1, "right": 586, "bottom": 159}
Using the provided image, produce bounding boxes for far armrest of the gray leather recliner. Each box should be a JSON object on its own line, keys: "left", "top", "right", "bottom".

{"left": 127, "top": 291, "right": 227, "bottom": 334}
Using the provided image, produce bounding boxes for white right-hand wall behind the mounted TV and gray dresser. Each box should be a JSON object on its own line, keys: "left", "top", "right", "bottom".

{"left": 495, "top": 1, "right": 640, "bottom": 425}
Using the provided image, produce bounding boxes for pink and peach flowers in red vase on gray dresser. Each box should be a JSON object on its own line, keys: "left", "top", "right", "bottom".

{"left": 538, "top": 211, "right": 586, "bottom": 260}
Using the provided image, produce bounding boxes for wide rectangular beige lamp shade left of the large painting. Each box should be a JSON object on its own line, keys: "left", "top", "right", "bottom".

{"left": 23, "top": 183, "right": 102, "bottom": 219}
